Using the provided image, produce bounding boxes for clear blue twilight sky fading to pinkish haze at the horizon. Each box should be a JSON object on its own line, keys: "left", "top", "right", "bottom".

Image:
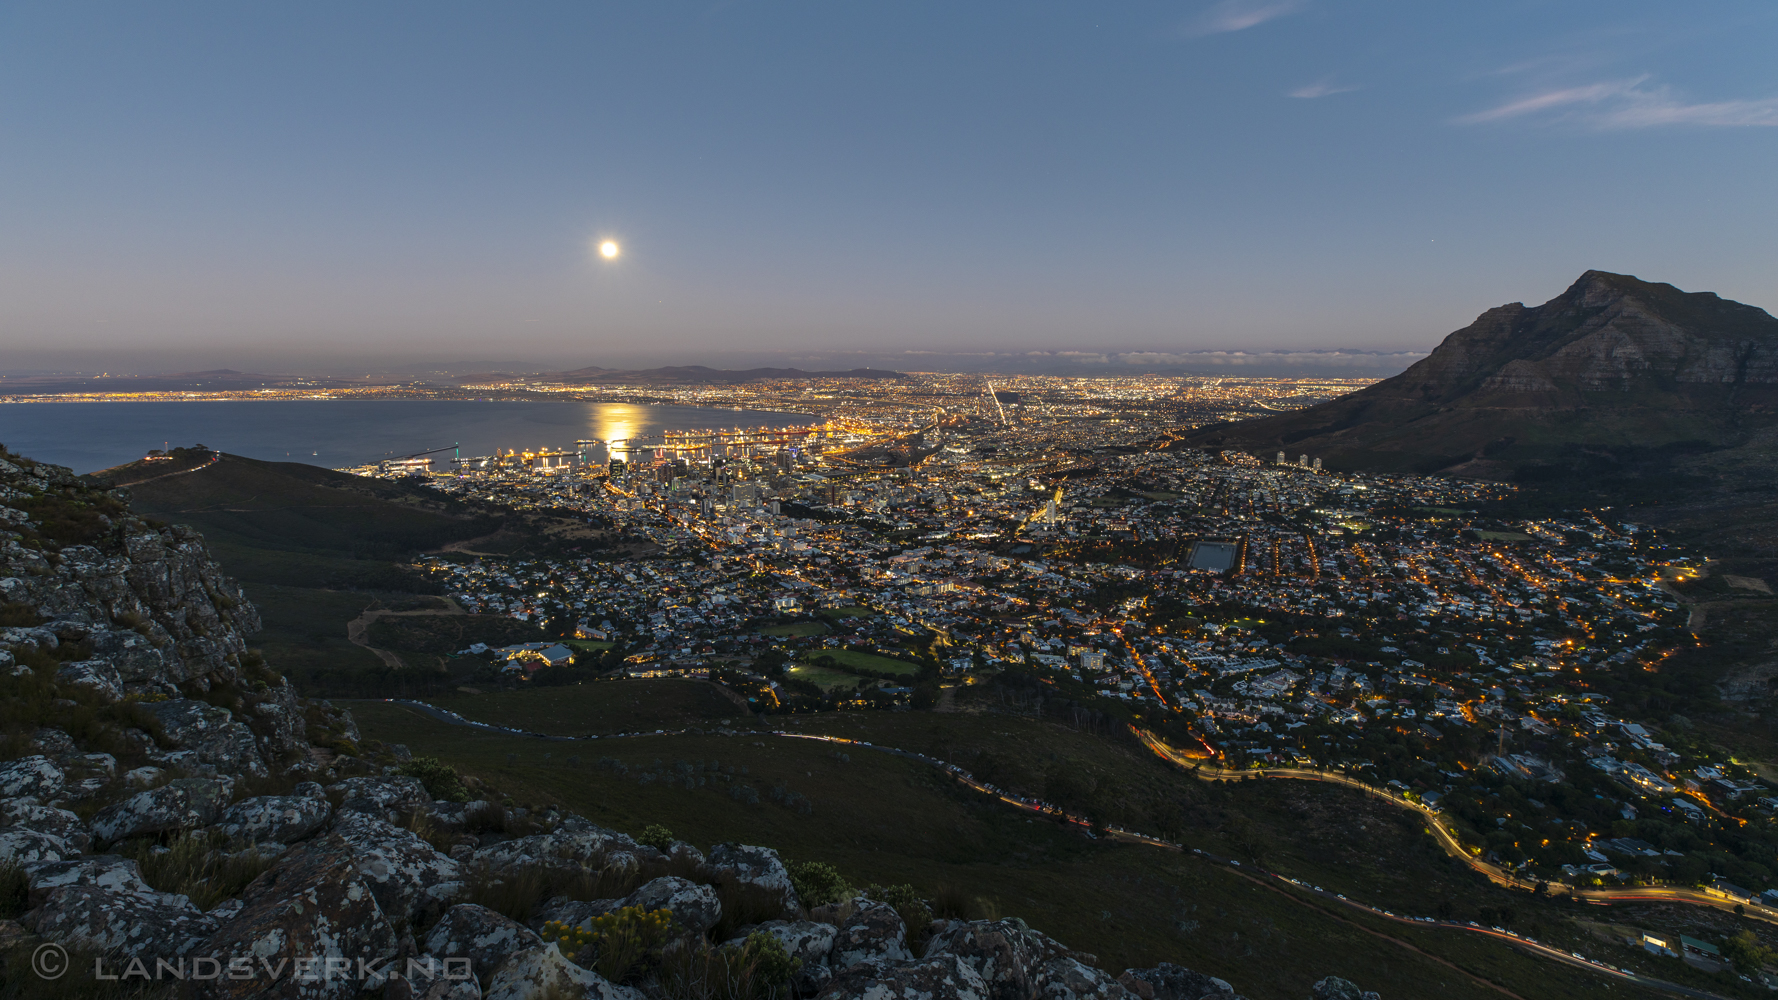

{"left": 0, "top": 0, "right": 1778, "bottom": 370}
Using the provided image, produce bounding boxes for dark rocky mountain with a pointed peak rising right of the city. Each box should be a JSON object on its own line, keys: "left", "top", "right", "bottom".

{"left": 1179, "top": 270, "right": 1778, "bottom": 480}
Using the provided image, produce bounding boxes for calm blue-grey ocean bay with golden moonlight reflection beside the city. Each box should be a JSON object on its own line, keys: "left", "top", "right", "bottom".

{"left": 0, "top": 399, "right": 809, "bottom": 473}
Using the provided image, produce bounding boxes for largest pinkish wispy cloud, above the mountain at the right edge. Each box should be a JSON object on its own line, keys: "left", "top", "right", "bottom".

{"left": 1456, "top": 77, "right": 1778, "bottom": 128}
